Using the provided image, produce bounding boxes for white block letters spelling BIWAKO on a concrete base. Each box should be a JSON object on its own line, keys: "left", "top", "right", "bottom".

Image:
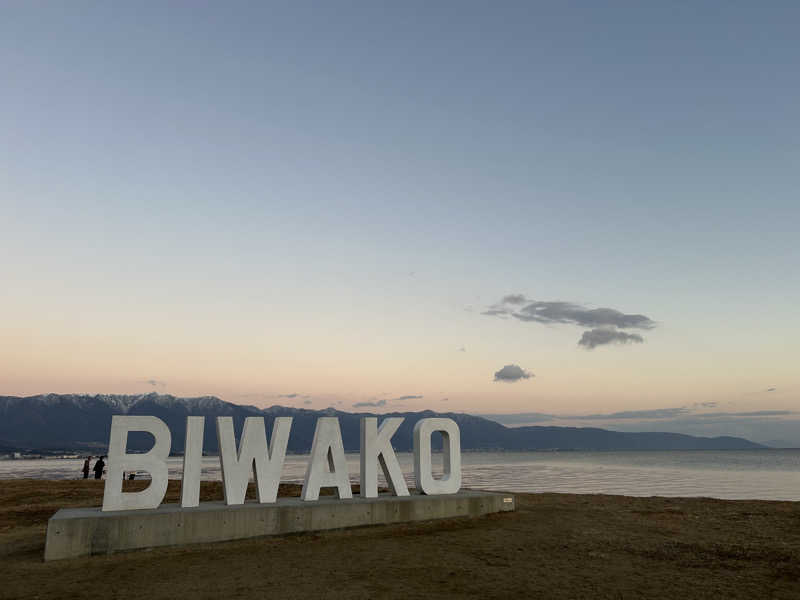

{"left": 103, "top": 415, "right": 461, "bottom": 511}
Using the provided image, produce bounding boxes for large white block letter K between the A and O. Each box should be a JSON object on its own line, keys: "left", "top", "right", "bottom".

{"left": 361, "top": 417, "right": 408, "bottom": 498}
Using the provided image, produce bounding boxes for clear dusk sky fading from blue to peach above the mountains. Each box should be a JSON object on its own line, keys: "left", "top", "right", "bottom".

{"left": 0, "top": 1, "right": 800, "bottom": 442}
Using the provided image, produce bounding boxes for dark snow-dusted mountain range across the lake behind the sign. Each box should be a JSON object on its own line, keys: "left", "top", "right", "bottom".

{"left": 0, "top": 393, "right": 764, "bottom": 454}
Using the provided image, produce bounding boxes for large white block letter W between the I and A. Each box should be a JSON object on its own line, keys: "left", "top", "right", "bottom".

{"left": 217, "top": 417, "right": 292, "bottom": 504}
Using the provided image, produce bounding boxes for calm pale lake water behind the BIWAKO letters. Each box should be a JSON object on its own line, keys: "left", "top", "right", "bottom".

{"left": 0, "top": 450, "right": 800, "bottom": 500}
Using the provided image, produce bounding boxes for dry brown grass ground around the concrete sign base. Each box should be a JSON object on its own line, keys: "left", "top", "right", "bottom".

{"left": 0, "top": 480, "right": 800, "bottom": 600}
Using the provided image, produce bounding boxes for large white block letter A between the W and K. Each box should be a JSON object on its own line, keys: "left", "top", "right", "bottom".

{"left": 301, "top": 417, "right": 353, "bottom": 500}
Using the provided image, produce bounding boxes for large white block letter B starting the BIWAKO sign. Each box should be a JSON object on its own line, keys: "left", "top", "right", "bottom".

{"left": 103, "top": 415, "right": 172, "bottom": 511}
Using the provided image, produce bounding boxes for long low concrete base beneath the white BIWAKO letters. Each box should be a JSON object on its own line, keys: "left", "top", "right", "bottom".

{"left": 44, "top": 491, "right": 515, "bottom": 560}
